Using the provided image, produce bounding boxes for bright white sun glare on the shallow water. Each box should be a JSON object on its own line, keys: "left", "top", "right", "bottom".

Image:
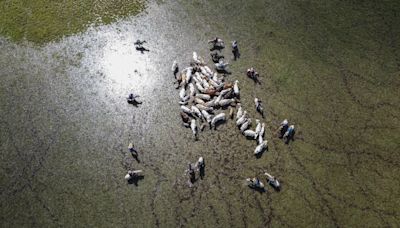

{"left": 59, "top": 20, "right": 161, "bottom": 101}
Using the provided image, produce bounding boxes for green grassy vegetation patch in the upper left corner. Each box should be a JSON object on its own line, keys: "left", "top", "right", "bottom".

{"left": 0, "top": 0, "right": 144, "bottom": 44}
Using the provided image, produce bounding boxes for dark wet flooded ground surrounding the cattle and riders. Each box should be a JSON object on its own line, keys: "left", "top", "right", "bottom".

{"left": 0, "top": 1, "right": 400, "bottom": 227}
